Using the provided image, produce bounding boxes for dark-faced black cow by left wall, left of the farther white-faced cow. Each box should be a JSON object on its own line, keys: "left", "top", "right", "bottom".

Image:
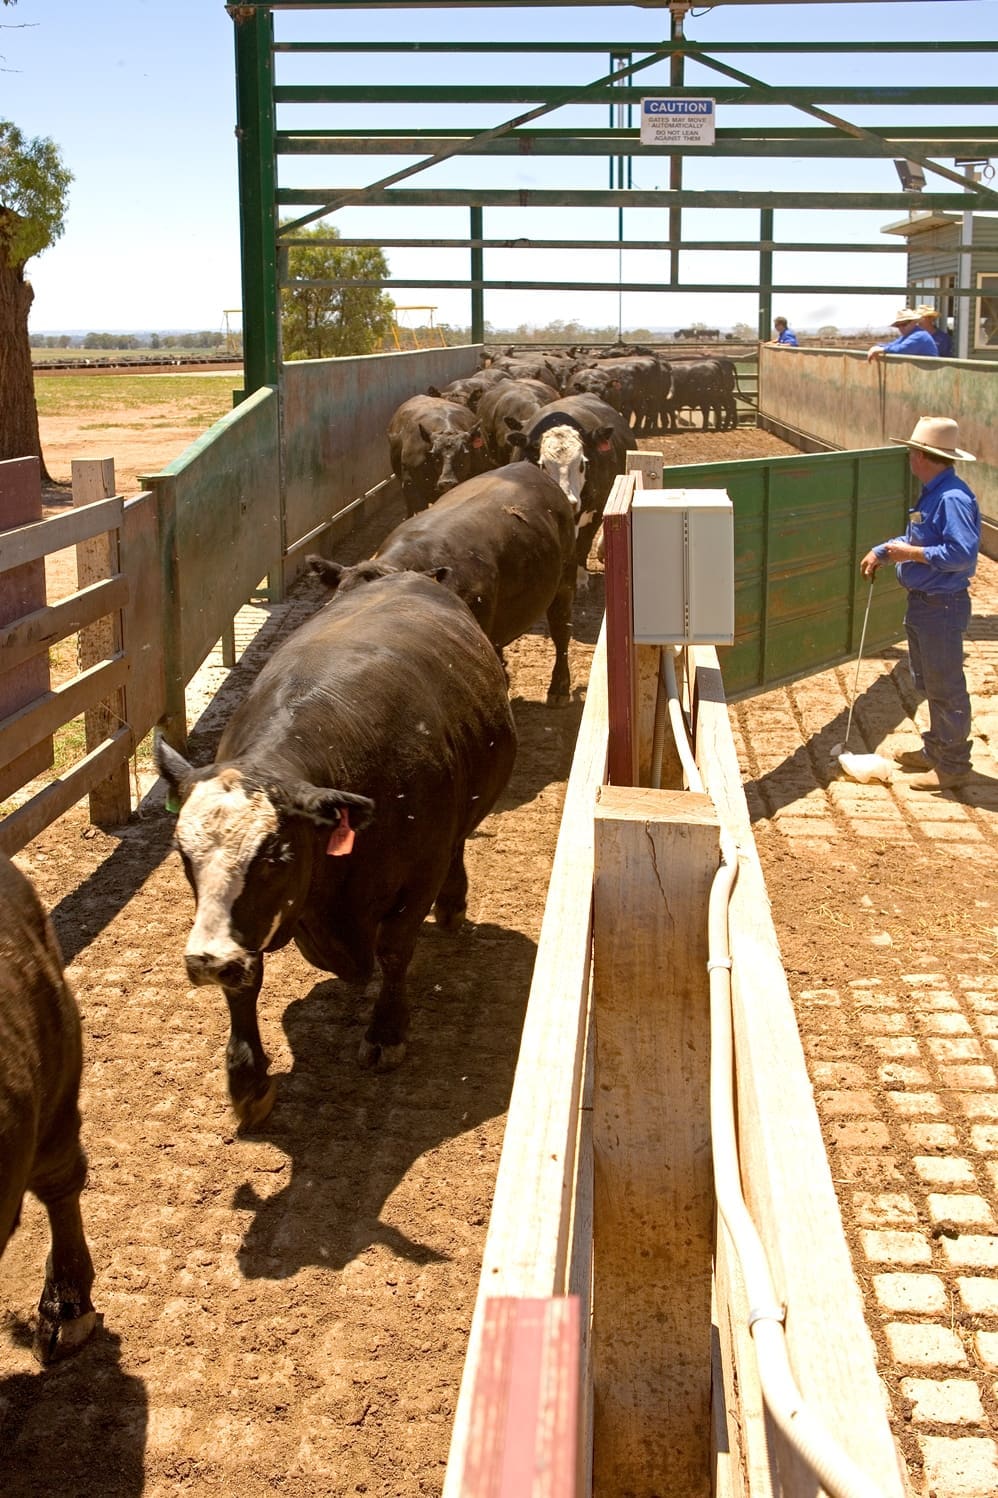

{"left": 388, "top": 395, "right": 489, "bottom": 515}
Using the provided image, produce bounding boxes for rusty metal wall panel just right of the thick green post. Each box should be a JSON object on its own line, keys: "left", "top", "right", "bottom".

{"left": 282, "top": 345, "right": 480, "bottom": 547}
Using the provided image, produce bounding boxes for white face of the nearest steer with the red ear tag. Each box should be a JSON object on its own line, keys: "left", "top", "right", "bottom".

{"left": 177, "top": 768, "right": 283, "bottom": 983}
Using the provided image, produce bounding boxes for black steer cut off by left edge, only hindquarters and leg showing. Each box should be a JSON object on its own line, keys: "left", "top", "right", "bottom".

{"left": 0, "top": 854, "right": 97, "bottom": 1363}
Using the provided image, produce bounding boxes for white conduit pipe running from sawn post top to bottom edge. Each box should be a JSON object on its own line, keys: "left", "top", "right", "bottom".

{"left": 707, "top": 831, "right": 883, "bottom": 1498}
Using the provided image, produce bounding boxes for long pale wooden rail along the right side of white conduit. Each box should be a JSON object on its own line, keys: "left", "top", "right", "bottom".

{"left": 691, "top": 646, "right": 904, "bottom": 1498}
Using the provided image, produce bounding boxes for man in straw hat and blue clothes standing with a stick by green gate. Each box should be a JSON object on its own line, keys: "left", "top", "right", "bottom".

{"left": 860, "top": 416, "right": 980, "bottom": 791}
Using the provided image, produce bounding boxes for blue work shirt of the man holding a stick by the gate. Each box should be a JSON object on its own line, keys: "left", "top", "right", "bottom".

{"left": 874, "top": 467, "right": 980, "bottom": 593}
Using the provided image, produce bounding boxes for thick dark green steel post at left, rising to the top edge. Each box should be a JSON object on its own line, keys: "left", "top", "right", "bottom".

{"left": 226, "top": 4, "right": 280, "bottom": 395}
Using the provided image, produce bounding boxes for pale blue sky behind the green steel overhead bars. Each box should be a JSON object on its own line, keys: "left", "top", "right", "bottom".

{"left": 0, "top": 0, "right": 998, "bottom": 331}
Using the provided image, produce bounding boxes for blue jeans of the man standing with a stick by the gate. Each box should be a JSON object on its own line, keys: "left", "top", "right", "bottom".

{"left": 905, "top": 589, "right": 971, "bottom": 770}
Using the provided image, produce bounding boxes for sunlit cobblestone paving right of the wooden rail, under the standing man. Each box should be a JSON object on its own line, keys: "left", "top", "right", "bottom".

{"left": 731, "top": 560, "right": 998, "bottom": 1498}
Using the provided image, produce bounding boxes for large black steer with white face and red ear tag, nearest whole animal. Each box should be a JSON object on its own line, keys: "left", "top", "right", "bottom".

{"left": 156, "top": 572, "right": 515, "bottom": 1125}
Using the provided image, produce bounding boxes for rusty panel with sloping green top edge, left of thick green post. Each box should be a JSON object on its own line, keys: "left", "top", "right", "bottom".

{"left": 142, "top": 388, "right": 282, "bottom": 682}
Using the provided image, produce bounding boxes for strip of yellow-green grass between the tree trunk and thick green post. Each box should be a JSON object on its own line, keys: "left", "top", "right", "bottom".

{"left": 34, "top": 370, "right": 240, "bottom": 427}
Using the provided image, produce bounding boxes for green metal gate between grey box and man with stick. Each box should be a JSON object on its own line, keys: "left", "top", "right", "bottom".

{"left": 662, "top": 448, "right": 911, "bottom": 697}
